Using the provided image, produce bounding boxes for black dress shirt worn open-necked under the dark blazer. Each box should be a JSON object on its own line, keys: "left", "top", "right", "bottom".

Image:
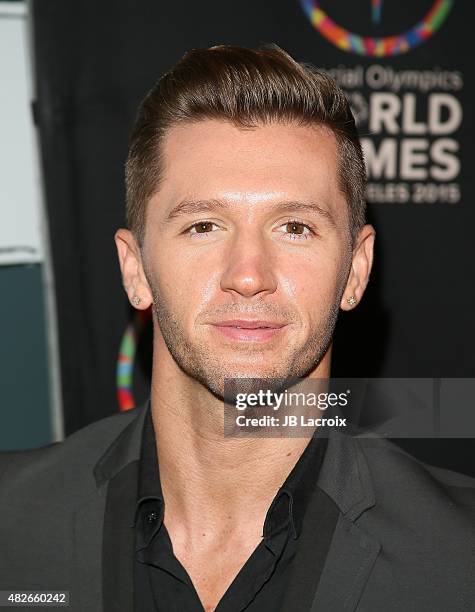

{"left": 134, "top": 411, "right": 339, "bottom": 612}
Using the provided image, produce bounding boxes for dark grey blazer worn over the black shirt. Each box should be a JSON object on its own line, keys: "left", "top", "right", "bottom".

{"left": 0, "top": 407, "right": 475, "bottom": 612}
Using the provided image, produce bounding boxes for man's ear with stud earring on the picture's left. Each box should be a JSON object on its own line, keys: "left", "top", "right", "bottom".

{"left": 114, "top": 229, "right": 153, "bottom": 310}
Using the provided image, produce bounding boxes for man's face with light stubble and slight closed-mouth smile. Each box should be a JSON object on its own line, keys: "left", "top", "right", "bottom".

{"left": 122, "top": 120, "right": 372, "bottom": 396}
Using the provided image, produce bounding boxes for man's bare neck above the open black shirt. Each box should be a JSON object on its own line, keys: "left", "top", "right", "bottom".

{"left": 151, "top": 340, "right": 330, "bottom": 533}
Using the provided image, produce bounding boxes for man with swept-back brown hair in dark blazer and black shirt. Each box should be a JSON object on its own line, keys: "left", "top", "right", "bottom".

{"left": 0, "top": 46, "right": 475, "bottom": 612}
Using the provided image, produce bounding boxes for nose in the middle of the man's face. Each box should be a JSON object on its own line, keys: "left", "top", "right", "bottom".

{"left": 221, "top": 228, "right": 277, "bottom": 298}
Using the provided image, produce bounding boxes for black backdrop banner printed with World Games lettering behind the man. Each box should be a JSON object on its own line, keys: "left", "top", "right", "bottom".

{"left": 33, "top": 0, "right": 475, "bottom": 469}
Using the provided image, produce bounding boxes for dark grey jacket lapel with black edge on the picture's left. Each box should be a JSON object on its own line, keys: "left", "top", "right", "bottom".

{"left": 71, "top": 404, "right": 148, "bottom": 612}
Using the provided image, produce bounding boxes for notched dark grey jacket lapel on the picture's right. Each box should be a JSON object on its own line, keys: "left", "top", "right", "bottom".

{"left": 311, "top": 429, "right": 381, "bottom": 612}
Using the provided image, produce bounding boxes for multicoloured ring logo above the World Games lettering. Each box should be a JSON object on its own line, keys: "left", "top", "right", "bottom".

{"left": 300, "top": 0, "right": 454, "bottom": 57}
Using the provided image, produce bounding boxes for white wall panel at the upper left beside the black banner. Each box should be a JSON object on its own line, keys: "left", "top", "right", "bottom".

{"left": 0, "top": 2, "right": 43, "bottom": 264}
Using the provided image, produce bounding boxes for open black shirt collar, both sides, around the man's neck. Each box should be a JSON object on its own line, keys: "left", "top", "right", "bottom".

{"left": 134, "top": 403, "right": 328, "bottom": 547}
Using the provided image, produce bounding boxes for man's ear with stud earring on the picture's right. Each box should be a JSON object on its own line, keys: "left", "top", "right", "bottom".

{"left": 340, "top": 225, "right": 376, "bottom": 310}
